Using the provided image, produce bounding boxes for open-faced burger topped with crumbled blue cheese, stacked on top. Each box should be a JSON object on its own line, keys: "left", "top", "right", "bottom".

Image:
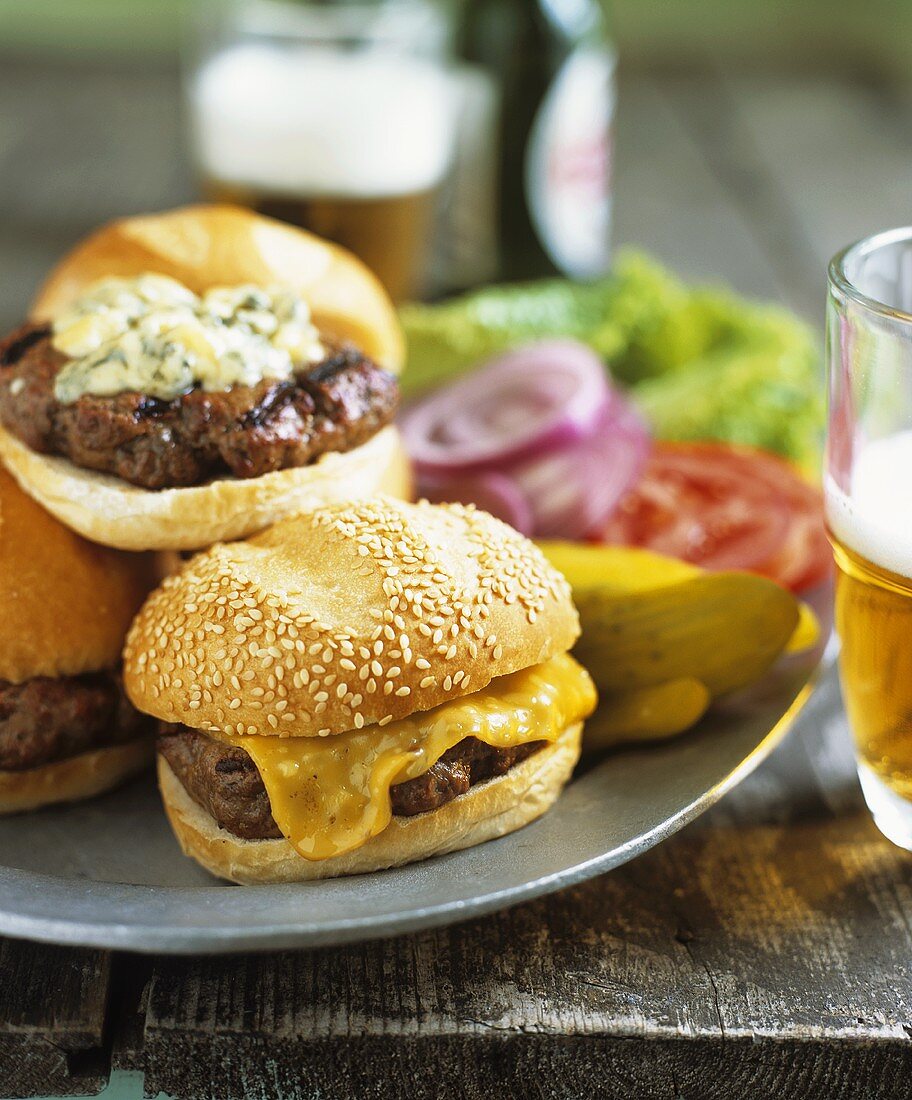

{"left": 0, "top": 206, "right": 410, "bottom": 550}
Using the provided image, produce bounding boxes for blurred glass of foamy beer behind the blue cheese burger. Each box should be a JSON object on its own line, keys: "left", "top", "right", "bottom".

{"left": 187, "top": 0, "right": 455, "bottom": 299}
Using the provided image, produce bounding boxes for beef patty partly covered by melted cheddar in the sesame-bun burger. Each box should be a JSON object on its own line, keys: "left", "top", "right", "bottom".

{"left": 158, "top": 723, "right": 545, "bottom": 840}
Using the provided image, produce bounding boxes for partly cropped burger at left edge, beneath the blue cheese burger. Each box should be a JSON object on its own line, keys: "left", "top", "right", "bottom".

{"left": 0, "top": 459, "right": 154, "bottom": 814}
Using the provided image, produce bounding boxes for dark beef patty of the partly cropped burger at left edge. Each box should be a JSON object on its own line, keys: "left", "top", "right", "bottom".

{"left": 0, "top": 672, "right": 152, "bottom": 771}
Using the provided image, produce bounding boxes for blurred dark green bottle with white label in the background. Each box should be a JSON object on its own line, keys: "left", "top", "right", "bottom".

{"left": 455, "top": 0, "right": 615, "bottom": 279}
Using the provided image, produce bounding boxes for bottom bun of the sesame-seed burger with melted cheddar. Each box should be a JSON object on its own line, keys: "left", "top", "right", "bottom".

{"left": 158, "top": 723, "right": 583, "bottom": 886}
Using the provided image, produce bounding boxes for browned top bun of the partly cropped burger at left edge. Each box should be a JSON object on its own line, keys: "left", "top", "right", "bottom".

{"left": 0, "top": 468, "right": 154, "bottom": 683}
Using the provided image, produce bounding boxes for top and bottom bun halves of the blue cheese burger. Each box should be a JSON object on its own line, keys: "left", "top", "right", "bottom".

{"left": 0, "top": 206, "right": 411, "bottom": 550}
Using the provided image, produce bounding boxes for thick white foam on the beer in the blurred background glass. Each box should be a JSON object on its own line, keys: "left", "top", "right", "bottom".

{"left": 190, "top": 45, "right": 455, "bottom": 198}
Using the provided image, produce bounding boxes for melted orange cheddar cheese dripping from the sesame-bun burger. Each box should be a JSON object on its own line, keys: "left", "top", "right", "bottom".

{"left": 213, "top": 653, "right": 596, "bottom": 860}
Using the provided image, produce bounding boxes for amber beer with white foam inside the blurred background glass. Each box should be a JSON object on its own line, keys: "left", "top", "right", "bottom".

{"left": 189, "top": 43, "right": 453, "bottom": 300}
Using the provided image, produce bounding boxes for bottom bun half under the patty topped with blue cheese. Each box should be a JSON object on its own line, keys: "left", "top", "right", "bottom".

{"left": 0, "top": 425, "right": 411, "bottom": 550}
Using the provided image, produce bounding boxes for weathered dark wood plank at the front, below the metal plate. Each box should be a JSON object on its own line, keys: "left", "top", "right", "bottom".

{"left": 138, "top": 792, "right": 912, "bottom": 1100}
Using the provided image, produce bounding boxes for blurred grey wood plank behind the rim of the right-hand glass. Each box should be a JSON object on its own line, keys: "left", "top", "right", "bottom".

{"left": 661, "top": 73, "right": 912, "bottom": 323}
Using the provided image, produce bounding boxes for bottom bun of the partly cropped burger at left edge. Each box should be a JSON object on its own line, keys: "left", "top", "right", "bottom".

{"left": 0, "top": 738, "right": 153, "bottom": 814}
